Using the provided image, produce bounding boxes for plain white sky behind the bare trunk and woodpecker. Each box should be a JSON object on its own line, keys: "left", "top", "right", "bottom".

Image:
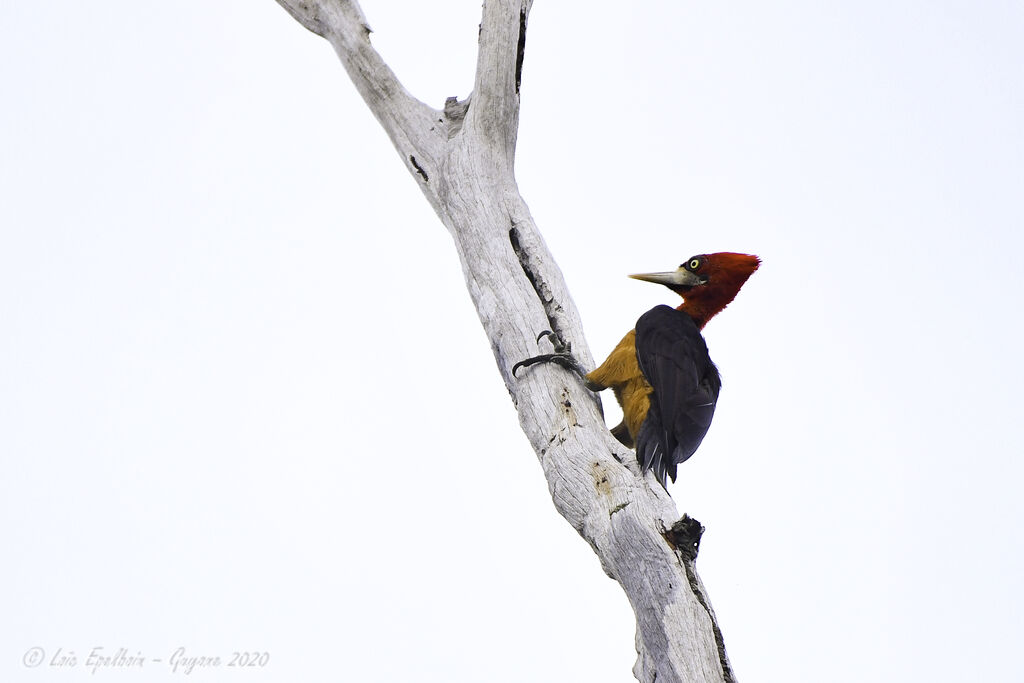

{"left": 0, "top": 0, "right": 1024, "bottom": 682}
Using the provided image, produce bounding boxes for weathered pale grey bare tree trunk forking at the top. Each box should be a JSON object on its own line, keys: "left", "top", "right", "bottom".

{"left": 278, "top": 0, "right": 734, "bottom": 683}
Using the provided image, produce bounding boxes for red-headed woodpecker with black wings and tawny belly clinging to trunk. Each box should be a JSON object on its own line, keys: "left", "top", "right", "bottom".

{"left": 512, "top": 252, "right": 761, "bottom": 486}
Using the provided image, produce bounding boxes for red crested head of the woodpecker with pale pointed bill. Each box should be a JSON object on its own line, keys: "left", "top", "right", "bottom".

{"left": 630, "top": 252, "right": 761, "bottom": 328}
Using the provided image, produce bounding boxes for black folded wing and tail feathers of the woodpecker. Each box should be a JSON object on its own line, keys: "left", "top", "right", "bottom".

{"left": 636, "top": 306, "right": 722, "bottom": 486}
